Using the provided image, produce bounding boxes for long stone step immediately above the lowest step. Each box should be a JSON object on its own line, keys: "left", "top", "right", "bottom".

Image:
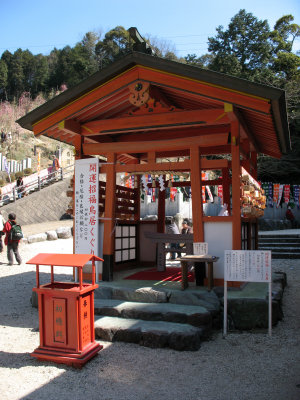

{"left": 94, "top": 299, "right": 212, "bottom": 336}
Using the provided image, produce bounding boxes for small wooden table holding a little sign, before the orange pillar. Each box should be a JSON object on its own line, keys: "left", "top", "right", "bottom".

{"left": 177, "top": 254, "right": 219, "bottom": 291}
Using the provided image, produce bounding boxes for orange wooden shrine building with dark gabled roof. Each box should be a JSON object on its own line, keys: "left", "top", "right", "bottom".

{"left": 17, "top": 52, "right": 290, "bottom": 281}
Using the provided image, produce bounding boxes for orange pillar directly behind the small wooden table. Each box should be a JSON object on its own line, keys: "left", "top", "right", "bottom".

{"left": 190, "top": 146, "right": 204, "bottom": 242}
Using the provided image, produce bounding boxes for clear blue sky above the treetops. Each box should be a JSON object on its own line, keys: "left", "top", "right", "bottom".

{"left": 0, "top": 0, "right": 300, "bottom": 57}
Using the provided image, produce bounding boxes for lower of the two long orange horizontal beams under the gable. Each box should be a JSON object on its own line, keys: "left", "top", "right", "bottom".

{"left": 83, "top": 133, "right": 228, "bottom": 155}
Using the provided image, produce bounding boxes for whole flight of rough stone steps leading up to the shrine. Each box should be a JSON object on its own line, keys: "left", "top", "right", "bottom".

{"left": 95, "top": 282, "right": 220, "bottom": 350}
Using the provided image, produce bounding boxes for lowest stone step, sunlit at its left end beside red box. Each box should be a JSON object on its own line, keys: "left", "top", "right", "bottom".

{"left": 95, "top": 316, "right": 205, "bottom": 351}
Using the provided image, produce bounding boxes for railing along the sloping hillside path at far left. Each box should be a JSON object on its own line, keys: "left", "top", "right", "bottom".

{"left": 0, "top": 164, "right": 74, "bottom": 207}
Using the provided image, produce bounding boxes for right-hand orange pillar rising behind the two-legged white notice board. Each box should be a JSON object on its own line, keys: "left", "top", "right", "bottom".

{"left": 230, "top": 121, "right": 241, "bottom": 250}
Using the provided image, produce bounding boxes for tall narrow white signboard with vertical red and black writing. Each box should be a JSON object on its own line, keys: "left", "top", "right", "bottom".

{"left": 74, "top": 158, "right": 100, "bottom": 281}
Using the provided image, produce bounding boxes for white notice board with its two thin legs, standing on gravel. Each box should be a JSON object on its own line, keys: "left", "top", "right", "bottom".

{"left": 223, "top": 250, "right": 272, "bottom": 336}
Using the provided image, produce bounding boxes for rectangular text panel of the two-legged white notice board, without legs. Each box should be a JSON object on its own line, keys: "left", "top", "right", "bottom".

{"left": 224, "top": 250, "right": 272, "bottom": 282}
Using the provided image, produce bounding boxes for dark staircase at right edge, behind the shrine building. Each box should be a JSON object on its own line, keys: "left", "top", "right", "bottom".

{"left": 258, "top": 233, "right": 300, "bottom": 259}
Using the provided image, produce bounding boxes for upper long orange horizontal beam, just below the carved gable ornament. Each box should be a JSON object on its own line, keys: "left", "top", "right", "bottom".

{"left": 82, "top": 109, "right": 229, "bottom": 136}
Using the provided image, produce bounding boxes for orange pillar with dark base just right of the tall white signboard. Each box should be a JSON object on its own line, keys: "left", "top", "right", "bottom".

{"left": 102, "top": 153, "right": 116, "bottom": 281}
